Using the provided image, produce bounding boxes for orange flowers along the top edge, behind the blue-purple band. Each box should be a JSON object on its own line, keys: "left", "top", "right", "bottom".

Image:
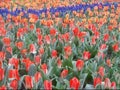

{"left": 0, "top": 0, "right": 109, "bottom": 10}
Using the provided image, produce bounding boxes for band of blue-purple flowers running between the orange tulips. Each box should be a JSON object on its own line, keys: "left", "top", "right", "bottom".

{"left": 0, "top": 3, "right": 118, "bottom": 17}
